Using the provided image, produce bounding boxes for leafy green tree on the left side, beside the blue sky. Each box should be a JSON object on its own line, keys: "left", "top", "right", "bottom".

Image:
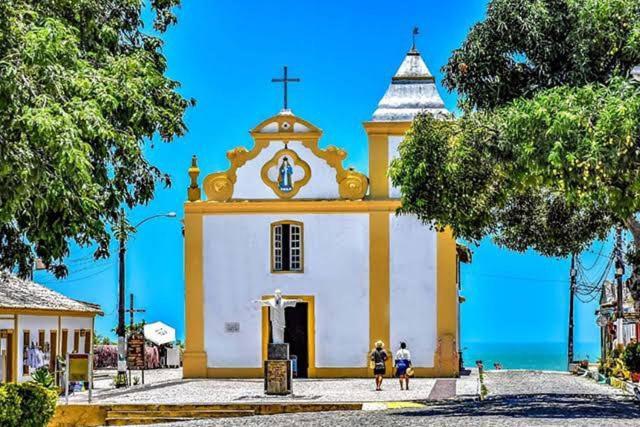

{"left": 0, "top": 0, "right": 193, "bottom": 276}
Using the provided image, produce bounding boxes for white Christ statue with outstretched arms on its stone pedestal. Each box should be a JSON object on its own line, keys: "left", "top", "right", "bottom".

{"left": 256, "top": 289, "right": 302, "bottom": 395}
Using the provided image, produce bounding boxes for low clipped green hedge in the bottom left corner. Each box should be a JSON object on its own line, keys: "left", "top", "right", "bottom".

{"left": 0, "top": 382, "right": 58, "bottom": 427}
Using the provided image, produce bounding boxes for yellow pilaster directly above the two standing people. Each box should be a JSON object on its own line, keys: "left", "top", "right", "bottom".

{"left": 369, "top": 212, "right": 392, "bottom": 374}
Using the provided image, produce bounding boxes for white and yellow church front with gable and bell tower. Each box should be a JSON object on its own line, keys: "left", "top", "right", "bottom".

{"left": 184, "top": 45, "right": 459, "bottom": 378}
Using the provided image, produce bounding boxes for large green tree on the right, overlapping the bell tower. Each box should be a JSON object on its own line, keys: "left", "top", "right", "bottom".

{"left": 390, "top": 0, "right": 640, "bottom": 264}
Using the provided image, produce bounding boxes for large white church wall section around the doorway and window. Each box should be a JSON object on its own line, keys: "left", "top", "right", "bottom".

{"left": 202, "top": 214, "right": 369, "bottom": 367}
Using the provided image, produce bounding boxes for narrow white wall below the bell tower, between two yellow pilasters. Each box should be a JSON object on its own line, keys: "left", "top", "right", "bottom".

{"left": 389, "top": 215, "right": 437, "bottom": 367}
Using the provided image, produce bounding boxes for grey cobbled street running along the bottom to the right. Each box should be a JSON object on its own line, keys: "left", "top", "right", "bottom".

{"left": 135, "top": 371, "right": 640, "bottom": 427}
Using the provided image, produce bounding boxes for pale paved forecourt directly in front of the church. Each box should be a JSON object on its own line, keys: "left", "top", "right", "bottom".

{"left": 70, "top": 369, "right": 478, "bottom": 404}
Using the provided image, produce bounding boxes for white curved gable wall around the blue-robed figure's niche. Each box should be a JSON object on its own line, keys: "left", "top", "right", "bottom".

{"left": 233, "top": 141, "right": 340, "bottom": 200}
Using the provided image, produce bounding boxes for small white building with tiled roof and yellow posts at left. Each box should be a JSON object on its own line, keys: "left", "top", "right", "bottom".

{"left": 0, "top": 271, "right": 103, "bottom": 382}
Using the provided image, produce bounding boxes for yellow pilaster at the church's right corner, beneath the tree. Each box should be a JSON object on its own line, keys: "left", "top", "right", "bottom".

{"left": 434, "top": 229, "right": 459, "bottom": 377}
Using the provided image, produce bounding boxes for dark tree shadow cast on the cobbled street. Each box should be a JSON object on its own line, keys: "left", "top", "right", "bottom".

{"left": 400, "top": 394, "right": 640, "bottom": 420}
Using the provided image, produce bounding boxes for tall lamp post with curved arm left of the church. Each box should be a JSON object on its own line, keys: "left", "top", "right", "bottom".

{"left": 116, "top": 209, "right": 176, "bottom": 384}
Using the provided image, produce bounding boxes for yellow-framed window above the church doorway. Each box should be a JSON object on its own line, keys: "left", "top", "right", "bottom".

{"left": 271, "top": 221, "right": 304, "bottom": 273}
